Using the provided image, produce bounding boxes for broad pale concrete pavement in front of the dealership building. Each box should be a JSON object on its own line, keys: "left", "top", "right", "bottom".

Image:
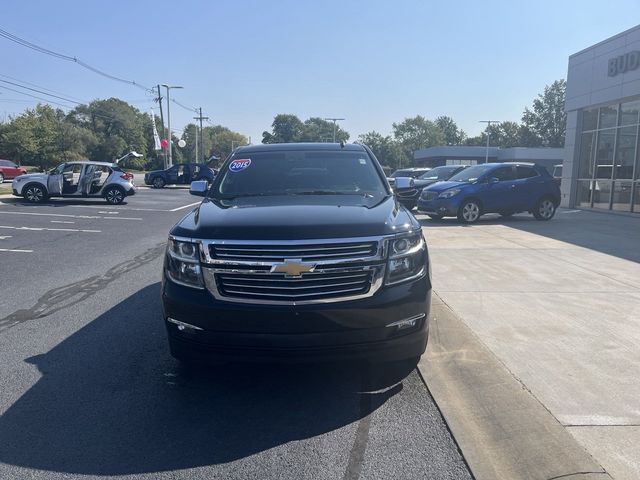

{"left": 419, "top": 210, "right": 640, "bottom": 479}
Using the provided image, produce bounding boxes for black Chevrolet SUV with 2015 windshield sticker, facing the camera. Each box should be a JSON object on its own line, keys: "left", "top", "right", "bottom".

{"left": 162, "top": 143, "right": 431, "bottom": 362}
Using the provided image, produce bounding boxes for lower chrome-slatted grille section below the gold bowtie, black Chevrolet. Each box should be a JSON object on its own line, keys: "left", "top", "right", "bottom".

{"left": 214, "top": 270, "right": 373, "bottom": 302}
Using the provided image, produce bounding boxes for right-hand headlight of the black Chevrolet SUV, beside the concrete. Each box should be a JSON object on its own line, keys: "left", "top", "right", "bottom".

{"left": 386, "top": 233, "right": 427, "bottom": 285}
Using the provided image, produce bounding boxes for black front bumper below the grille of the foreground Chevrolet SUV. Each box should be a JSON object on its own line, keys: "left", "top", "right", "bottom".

{"left": 162, "top": 275, "right": 431, "bottom": 362}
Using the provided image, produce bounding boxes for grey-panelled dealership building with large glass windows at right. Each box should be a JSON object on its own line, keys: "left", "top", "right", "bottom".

{"left": 562, "top": 25, "right": 640, "bottom": 213}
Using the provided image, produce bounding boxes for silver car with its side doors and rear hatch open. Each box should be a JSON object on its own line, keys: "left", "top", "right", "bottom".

{"left": 11, "top": 161, "right": 136, "bottom": 204}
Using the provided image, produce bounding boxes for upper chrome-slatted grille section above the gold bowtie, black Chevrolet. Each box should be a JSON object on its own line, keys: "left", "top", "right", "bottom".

{"left": 209, "top": 242, "right": 378, "bottom": 262}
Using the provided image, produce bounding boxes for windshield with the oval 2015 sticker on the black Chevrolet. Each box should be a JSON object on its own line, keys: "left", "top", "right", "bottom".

{"left": 212, "top": 150, "right": 387, "bottom": 198}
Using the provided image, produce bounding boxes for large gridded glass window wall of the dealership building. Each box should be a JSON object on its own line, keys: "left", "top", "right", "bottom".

{"left": 575, "top": 100, "right": 640, "bottom": 213}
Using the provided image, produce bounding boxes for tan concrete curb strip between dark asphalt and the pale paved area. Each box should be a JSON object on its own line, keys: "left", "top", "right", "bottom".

{"left": 418, "top": 296, "right": 611, "bottom": 480}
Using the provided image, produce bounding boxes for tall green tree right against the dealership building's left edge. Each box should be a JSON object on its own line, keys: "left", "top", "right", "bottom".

{"left": 522, "top": 80, "right": 567, "bottom": 147}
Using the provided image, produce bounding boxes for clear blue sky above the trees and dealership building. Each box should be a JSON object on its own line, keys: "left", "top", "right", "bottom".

{"left": 0, "top": 0, "right": 640, "bottom": 143}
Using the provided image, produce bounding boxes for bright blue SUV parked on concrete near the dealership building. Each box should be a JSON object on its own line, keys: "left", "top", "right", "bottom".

{"left": 418, "top": 163, "right": 560, "bottom": 223}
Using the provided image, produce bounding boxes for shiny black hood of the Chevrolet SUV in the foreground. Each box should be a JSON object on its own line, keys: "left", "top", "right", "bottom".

{"left": 171, "top": 195, "right": 420, "bottom": 240}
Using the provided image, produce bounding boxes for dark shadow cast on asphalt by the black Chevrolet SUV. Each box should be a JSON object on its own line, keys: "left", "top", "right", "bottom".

{"left": 0, "top": 284, "right": 410, "bottom": 475}
